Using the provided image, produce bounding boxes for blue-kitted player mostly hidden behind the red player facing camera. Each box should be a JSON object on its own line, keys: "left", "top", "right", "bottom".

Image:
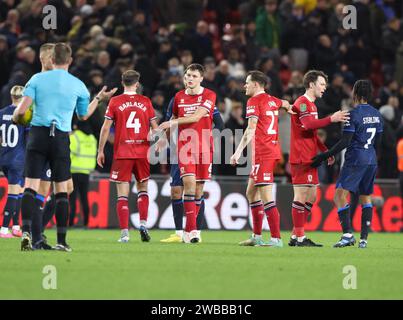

{"left": 161, "top": 92, "right": 224, "bottom": 243}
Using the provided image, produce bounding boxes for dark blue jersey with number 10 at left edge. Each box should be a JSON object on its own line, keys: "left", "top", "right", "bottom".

{"left": 0, "top": 105, "right": 27, "bottom": 165}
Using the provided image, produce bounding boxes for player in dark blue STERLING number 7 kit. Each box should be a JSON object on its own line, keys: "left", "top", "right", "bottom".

{"left": 312, "top": 80, "right": 383, "bottom": 248}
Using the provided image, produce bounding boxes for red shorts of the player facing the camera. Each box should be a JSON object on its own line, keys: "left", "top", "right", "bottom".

{"left": 178, "top": 153, "right": 213, "bottom": 181}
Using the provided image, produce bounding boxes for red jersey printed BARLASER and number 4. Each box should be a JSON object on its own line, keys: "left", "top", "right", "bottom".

{"left": 105, "top": 94, "right": 156, "bottom": 159}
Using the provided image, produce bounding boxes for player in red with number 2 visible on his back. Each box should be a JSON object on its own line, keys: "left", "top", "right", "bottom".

{"left": 230, "top": 71, "right": 293, "bottom": 247}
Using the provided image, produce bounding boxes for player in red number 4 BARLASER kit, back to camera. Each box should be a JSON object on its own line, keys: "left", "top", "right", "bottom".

{"left": 97, "top": 70, "right": 158, "bottom": 242}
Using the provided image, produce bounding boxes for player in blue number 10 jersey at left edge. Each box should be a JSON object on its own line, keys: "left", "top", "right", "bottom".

{"left": 0, "top": 86, "right": 26, "bottom": 238}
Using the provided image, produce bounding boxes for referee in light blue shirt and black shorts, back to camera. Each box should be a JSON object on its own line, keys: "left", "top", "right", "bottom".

{"left": 13, "top": 43, "right": 99, "bottom": 252}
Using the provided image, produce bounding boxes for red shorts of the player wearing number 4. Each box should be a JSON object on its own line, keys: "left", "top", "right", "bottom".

{"left": 110, "top": 158, "right": 150, "bottom": 182}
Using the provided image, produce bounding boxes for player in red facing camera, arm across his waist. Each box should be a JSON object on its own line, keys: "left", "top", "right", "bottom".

{"left": 160, "top": 64, "right": 216, "bottom": 243}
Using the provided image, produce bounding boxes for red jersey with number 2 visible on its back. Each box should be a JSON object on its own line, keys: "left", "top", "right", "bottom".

{"left": 246, "top": 92, "right": 282, "bottom": 159}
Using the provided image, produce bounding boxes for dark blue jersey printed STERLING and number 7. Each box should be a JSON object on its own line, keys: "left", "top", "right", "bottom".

{"left": 343, "top": 104, "right": 383, "bottom": 166}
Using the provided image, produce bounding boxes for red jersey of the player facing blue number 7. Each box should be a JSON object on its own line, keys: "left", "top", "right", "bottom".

{"left": 290, "top": 95, "right": 318, "bottom": 164}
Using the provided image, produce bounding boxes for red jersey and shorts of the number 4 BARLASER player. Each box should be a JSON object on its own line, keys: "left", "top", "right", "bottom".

{"left": 105, "top": 93, "right": 156, "bottom": 182}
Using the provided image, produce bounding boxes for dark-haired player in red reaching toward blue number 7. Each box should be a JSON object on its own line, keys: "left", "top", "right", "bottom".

{"left": 289, "top": 70, "right": 349, "bottom": 247}
